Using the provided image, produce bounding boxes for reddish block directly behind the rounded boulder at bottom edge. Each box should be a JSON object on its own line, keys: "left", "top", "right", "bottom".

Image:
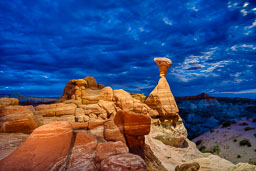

{"left": 96, "top": 141, "right": 128, "bottom": 162}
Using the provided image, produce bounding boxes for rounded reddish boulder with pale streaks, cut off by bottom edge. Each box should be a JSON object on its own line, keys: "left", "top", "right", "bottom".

{"left": 101, "top": 153, "right": 146, "bottom": 171}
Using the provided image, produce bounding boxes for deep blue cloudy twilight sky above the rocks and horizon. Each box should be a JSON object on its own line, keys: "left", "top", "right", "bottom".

{"left": 0, "top": 0, "right": 256, "bottom": 98}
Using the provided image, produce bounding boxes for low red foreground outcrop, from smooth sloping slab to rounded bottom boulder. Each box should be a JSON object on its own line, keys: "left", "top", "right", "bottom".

{"left": 0, "top": 122, "right": 146, "bottom": 171}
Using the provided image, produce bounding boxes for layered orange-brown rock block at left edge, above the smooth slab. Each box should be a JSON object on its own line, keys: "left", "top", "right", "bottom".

{"left": 0, "top": 105, "right": 39, "bottom": 133}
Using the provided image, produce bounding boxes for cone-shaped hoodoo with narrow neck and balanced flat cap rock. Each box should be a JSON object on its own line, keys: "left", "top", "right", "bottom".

{"left": 145, "top": 58, "right": 187, "bottom": 146}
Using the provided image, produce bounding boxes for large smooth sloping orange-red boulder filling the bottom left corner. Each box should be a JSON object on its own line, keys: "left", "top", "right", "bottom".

{"left": 0, "top": 122, "right": 72, "bottom": 171}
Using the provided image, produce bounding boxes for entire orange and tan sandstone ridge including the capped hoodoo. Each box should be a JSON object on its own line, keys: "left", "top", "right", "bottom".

{"left": 0, "top": 58, "right": 254, "bottom": 170}
